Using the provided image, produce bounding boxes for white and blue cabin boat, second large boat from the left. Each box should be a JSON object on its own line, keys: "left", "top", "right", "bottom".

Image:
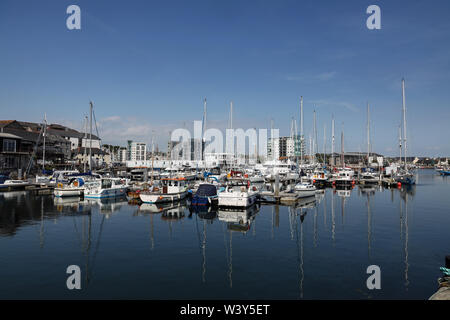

{"left": 84, "top": 178, "right": 128, "bottom": 199}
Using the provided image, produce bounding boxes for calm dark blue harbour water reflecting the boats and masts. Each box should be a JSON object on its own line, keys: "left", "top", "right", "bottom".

{"left": 0, "top": 170, "right": 450, "bottom": 299}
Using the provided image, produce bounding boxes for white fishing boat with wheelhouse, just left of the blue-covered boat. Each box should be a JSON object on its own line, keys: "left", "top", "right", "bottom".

{"left": 139, "top": 177, "right": 188, "bottom": 203}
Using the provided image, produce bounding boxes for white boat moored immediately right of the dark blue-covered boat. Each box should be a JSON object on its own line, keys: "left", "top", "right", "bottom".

{"left": 219, "top": 179, "right": 259, "bottom": 208}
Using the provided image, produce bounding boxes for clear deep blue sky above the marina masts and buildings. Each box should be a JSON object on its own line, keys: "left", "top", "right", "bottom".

{"left": 0, "top": 0, "right": 450, "bottom": 156}
